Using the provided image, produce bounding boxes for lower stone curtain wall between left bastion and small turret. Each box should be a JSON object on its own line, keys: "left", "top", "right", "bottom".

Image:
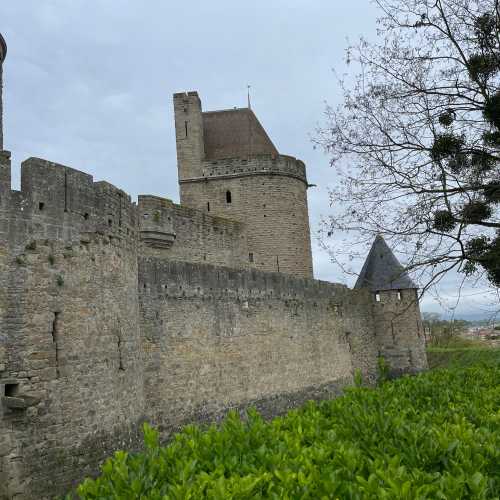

{"left": 139, "top": 258, "right": 376, "bottom": 430}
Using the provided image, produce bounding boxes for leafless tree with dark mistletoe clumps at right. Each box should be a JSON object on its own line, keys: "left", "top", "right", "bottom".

{"left": 316, "top": 0, "right": 500, "bottom": 300}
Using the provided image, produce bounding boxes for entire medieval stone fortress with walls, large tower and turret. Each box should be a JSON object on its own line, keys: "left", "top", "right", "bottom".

{"left": 0, "top": 33, "right": 426, "bottom": 499}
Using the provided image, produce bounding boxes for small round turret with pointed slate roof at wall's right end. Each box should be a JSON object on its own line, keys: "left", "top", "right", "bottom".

{"left": 354, "top": 235, "right": 427, "bottom": 375}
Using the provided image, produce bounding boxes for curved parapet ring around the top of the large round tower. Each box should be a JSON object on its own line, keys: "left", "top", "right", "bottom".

{"left": 179, "top": 155, "right": 307, "bottom": 184}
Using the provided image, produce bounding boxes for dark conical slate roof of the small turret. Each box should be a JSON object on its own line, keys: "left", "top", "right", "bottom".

{"left": 354, "top": 235, "right": 418, "bottom": 292}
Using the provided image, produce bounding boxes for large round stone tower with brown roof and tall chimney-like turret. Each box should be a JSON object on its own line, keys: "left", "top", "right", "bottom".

{"left": 174, "top": 92, "right": 313, "bottom": 278}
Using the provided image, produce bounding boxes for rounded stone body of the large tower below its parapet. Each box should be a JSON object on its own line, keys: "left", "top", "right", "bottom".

{"left": 181, "top": 167, "right": 312, "bottom": 278}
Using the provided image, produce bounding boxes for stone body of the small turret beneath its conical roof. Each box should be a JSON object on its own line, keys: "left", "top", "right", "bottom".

{"left": 372, "top": 289, "right": 427, "bottom": 375}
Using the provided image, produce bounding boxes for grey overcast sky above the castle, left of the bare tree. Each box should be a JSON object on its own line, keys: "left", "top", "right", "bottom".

{"left": 0, "top": 0, "right": 496, "bottom": 316}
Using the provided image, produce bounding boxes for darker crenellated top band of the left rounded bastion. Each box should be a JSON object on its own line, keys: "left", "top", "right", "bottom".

{"left": 0, "top": 151, "right": 138, "bottom": 247}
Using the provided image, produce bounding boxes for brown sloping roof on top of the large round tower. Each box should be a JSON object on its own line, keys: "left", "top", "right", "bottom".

{"left": 203, "top": 108, "right": 278, "bottom": 160}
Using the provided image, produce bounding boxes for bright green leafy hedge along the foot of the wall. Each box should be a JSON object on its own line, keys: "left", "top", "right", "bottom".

{"left": 73, "top": 366, "right": 500, "bottom": 500}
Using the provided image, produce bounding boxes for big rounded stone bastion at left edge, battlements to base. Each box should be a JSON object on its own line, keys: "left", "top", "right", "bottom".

{"left": 0, "top": 152, "right": 143, "bottom": 499}
